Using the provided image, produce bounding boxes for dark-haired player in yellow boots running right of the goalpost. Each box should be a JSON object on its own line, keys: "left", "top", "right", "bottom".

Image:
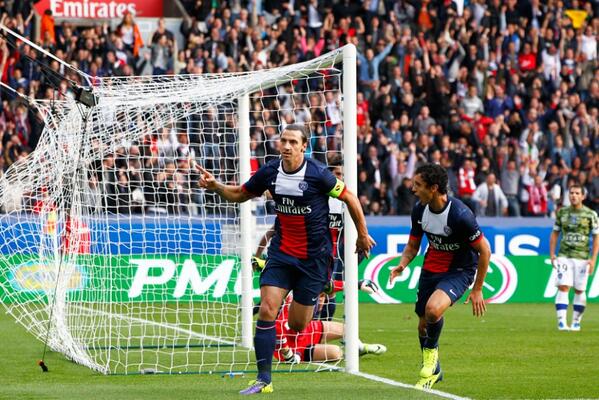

{"left": 389, "top": 164, "right": 491, "bottom": 389}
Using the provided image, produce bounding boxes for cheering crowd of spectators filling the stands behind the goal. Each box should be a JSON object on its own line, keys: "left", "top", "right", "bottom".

{"left": 0, "top": 0, "right": 599, "bottom": 217}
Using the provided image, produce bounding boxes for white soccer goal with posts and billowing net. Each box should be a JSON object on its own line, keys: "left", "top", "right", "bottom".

{"left": 0, "top": 27, "right": 358, "bottom": 374}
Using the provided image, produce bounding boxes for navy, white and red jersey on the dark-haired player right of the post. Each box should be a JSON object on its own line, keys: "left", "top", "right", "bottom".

{"left": 410, "top": 197, "right": 483, "bottom": 273}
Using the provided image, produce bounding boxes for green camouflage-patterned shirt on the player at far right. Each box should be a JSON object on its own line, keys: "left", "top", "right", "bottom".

{"left": 553, "top": 206, "right": 599, "bottom": 260}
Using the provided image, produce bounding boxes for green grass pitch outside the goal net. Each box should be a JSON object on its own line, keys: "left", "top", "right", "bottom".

{"left": 0, "top": 304, "right": 599, "bottom": 400}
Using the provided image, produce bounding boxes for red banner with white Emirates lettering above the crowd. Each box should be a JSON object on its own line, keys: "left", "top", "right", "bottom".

{"left": 35, "top": 0, "right": 163, "bottom": 18}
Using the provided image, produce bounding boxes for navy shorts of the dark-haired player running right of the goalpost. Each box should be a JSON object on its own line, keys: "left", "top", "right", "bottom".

{"left": 415, "top": 268, "right": 476, "bottom": 317}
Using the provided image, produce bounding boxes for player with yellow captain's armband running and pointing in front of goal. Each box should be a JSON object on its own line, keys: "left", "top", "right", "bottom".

{"left": 197, "top": 125, "right": 375, "bottom": 394}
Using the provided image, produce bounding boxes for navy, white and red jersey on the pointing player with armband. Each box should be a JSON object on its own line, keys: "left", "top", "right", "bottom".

{"left": 243, "top": 159, "right": 337, "bottom": 259}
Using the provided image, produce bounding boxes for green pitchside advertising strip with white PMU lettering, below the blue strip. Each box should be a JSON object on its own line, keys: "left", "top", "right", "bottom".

{"left": 0, "top": 254, "right": 599, "bottom": 303}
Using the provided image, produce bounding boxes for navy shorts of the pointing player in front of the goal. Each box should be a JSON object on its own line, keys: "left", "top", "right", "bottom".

{"left": 260, "top": 253, "right": 331, "bottom": 306}
